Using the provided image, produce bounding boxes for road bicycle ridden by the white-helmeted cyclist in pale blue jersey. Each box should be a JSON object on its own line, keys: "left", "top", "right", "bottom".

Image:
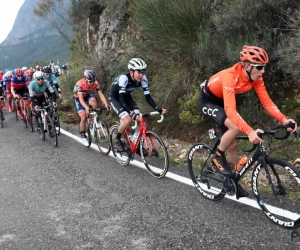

{"left": 36, "top": 102, "right": 58, "bottom": 147}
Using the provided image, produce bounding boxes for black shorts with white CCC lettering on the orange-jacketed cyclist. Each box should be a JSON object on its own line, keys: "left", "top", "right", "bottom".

{"left": 198, "top": 86, "right": 228, "bottom": 134}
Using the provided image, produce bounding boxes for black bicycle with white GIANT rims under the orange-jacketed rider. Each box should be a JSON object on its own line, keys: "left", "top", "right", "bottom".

{"left": 188, "top": 125, "right": 300, "bottom": 229}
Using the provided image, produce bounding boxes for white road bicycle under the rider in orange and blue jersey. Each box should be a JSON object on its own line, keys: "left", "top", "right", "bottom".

{"left": 79, "top": 107, "right": 110, "bottom": 155}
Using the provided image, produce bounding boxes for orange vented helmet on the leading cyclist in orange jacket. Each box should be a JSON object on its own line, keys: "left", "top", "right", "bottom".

{"left": 240, "top": 45, "right": 269, "bottom": 64}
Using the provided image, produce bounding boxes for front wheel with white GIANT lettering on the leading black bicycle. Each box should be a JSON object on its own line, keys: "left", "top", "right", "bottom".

{"left": 252, "top": 157, "right": 300, "bottom": 228}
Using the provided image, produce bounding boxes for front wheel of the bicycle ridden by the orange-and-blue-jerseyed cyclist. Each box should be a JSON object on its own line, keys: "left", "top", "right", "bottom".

{"left": 94, "top": 117, "right": 110, "bottom": 155}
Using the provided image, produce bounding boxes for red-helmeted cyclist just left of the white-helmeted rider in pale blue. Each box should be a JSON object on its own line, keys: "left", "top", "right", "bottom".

{"left": 11, "top": 69, "right": 29, "bottom": 118}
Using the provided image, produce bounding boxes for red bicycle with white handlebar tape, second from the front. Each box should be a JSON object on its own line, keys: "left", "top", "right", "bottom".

{"left": 110, "top": 111, "right": 169, "bottom": 178}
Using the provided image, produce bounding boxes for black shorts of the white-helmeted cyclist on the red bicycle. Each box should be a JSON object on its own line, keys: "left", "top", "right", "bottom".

{"left": 108, "top": 94, "right": 140, "bottom": 119}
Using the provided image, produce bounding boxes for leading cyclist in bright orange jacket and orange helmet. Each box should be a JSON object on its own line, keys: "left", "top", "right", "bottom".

{"left": 199, "top": 46, "right": 297, "bottom": 197}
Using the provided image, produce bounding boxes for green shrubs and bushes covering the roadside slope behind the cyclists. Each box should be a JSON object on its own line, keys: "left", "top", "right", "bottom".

{"left": 34, "top": 0, "right": 300, "bottom": 140}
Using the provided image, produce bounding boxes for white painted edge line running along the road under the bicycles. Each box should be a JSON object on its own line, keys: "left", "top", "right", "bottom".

{"left": 60, "top": 129, "right": 300, "bottom": 220}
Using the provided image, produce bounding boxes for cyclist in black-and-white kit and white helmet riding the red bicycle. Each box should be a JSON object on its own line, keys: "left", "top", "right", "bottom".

{"left": 109, "top": 58, "right": 167, "bottom": 152}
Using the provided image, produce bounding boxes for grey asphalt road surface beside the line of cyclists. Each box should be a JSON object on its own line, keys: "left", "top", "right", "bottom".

{"left": 0, "top": 112, "right": 300, "bottom": 250}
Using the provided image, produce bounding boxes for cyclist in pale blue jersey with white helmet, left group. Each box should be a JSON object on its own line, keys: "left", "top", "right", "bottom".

{"left": 28, "top": 71, "right": 56, "bottom": 130}
